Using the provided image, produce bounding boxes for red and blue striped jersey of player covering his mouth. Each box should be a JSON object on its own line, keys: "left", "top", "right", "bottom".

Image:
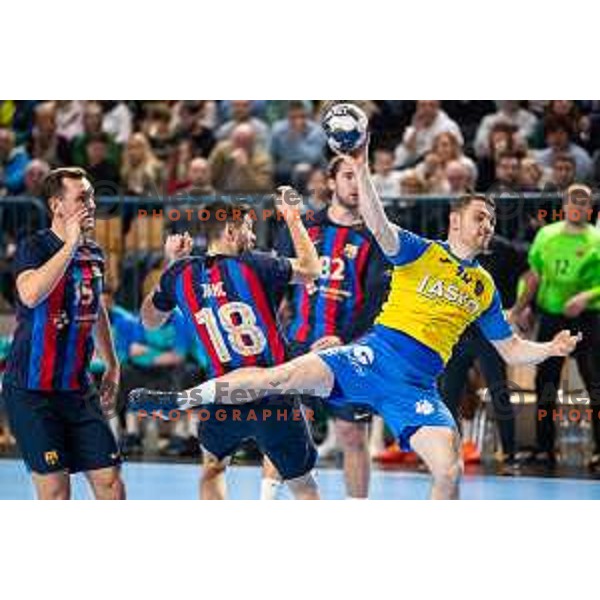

{"left": 5, "top": 229, "right": 104, "bottom": 391}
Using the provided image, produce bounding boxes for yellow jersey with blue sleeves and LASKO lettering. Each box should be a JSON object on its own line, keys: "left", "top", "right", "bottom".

{"left": 376, "top": 230, "right": 512, "bottom": 363}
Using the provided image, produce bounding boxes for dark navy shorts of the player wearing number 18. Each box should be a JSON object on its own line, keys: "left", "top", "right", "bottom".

{"left": 197, "top": 397, "right": 317, "bottom": 479}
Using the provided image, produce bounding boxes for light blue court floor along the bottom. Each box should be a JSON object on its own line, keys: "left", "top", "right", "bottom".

{"left": 0, "top": 459, "right": 600, "bottom": 500}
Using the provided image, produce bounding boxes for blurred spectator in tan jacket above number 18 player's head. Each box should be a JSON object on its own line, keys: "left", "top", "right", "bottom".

{"left": 209, "top": 123, "right": 273, "bottom": 193}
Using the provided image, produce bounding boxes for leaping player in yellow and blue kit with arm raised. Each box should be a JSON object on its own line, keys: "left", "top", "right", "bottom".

{"left": 130, "top": 148, "right": 579, "bottom": 499}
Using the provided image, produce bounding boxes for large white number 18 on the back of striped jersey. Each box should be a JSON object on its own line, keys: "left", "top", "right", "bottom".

{"left": 195, "top": 302, "right": 267, "bottom": 363}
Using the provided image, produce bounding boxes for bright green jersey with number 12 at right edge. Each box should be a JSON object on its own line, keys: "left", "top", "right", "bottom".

{"left": 529, "top": 221, "right": 600, "bottom": 315}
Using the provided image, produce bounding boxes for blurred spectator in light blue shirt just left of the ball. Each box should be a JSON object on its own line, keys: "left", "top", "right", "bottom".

{"left": 271, "top": 100, "right": 327, "bottom": 186}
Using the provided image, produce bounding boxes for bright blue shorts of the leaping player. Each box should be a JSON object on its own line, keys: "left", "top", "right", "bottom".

{"left": 317, "top": 325, "right": 456, "bottom": 450}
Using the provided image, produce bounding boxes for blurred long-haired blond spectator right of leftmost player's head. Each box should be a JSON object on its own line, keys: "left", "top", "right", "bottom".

{"left": 121, "top": 133, "right": 163, "bottom": 196}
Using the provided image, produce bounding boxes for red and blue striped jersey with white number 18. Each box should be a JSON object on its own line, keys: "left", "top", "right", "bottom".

{"left": 153, "top": 252, "right": 292, "bottom": 377}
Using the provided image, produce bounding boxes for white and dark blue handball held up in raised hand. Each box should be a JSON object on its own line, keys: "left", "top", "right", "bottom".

{"left": 321, "top": 103, "right": 369, "bottom": 154}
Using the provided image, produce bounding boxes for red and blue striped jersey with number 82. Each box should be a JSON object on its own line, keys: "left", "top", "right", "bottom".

{"left": 275, "top": 210, "right": 391, "bottom": 349}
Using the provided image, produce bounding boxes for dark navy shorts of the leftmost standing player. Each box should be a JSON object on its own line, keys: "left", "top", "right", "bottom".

{"left": 2, "top": 385, "right": 120, "bottom": 474}
